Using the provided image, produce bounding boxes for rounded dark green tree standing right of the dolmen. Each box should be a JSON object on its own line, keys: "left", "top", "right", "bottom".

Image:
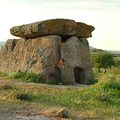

{"left": 92, "top": 51, "right": 114, "bottom": 72}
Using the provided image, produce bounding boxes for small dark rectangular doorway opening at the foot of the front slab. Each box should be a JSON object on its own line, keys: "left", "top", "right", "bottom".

{"left": 74, "top": 67, "right": 85, "bottom": 84}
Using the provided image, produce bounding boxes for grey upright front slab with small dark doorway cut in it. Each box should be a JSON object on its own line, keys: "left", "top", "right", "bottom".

{"left": 61, "top": 37, "right": 94, "bottom": 84}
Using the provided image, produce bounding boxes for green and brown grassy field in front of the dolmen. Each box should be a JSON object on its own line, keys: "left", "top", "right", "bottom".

{"left": 0, "top": 68, "right": 120, "bottom": 120}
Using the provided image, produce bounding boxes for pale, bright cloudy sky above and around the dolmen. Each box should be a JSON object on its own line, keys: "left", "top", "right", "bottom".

{"left": 0, "top": 0, "right": 120, "bottom": 51}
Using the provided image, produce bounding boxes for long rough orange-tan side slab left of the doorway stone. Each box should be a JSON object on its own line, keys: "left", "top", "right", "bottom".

{"left": 0, "top": 35, "right": 61, "bottom": 79}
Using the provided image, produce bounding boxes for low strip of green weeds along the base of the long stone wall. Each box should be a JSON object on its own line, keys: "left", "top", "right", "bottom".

{"left": 0, "top": 70, "right": 74, "bottom": 85}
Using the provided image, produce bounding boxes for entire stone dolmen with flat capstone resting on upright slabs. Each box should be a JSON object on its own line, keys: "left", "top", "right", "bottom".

{"left": 0, "top": 19, "right": 95, "bottom": 84}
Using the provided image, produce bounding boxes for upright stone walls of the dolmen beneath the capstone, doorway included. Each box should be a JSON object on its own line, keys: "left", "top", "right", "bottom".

{"left": 0, "top": 35, "right": 94, "bottom": 84}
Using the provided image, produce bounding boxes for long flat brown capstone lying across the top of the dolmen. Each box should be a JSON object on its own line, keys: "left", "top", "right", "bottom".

{"left": 10, "top": 19, "right": 95, "bottom": 38}
